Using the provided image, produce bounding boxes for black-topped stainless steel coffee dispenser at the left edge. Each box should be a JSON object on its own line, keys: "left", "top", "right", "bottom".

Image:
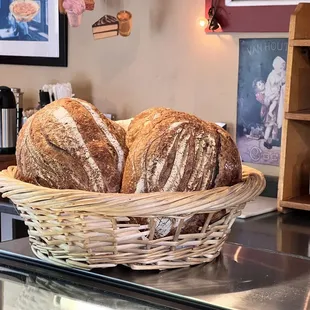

{"left": 0, "top": 86, "right": 17, "bottom": 154}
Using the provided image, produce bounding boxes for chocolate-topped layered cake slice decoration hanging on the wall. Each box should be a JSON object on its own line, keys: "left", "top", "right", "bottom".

{"left": 92, "top": 15, "right": 119, "bottom": 40}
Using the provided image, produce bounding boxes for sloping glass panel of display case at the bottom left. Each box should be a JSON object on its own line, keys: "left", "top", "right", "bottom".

{"left": 0, "top": 266, "right": 170, "bottom": 310}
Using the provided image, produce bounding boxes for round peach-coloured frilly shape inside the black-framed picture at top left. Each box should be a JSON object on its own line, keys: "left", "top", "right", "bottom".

{"left": 10, "top": 0, "right": 40, "bottom": 22}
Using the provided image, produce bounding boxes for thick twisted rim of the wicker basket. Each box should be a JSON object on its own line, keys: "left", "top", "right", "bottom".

{"left": 0, "top": 166, "right": 266, "bottom": 217}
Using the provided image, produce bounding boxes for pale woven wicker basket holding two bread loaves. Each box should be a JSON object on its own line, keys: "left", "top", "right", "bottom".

{"left": 0, "top": 166, "right": 265, "bottom": 270}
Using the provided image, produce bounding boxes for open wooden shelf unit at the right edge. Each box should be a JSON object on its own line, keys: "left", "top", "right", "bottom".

{"left": 278, "top": 3, "right": 310, "bottom": 212}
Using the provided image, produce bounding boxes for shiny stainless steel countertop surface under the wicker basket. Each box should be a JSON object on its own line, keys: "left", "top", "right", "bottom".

{"left": 0, "top": 239, "right": 310, "bottom": 310}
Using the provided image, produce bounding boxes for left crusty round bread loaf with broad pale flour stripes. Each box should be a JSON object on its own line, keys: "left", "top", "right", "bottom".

{"left": 16, "top": 98, "right": 128, "bottom": 192}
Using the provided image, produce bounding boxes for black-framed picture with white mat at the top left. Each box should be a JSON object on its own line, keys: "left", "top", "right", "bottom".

{"left": 0, "top": 0, "right": 68, "bottom": 67}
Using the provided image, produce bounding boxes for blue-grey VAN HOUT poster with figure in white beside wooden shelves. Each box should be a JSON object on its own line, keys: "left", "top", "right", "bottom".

{"left": 237, "top": 38, "right": 288, "bottom": 166}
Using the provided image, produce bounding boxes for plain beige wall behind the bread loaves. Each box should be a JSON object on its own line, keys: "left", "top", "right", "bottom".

{"left": 0, "top": 0, "right": 287, "bottom": 174}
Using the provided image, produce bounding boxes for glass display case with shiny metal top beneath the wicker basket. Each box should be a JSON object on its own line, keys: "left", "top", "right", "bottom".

{"left": 0, "top": 238, "right": 310, "bottom": 310}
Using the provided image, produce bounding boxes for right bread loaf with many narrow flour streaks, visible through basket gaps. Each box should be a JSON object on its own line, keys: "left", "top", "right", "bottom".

{"left": 122, "top": 108, "right": 242, "bottom": 238}
